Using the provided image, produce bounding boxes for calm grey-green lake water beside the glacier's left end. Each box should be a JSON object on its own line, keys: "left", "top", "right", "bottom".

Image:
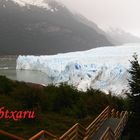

{"left": 0, "top": 56, "right": 52, "bottom": 85}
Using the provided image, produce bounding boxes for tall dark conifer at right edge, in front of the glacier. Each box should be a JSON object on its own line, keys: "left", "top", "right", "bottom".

{"left": 124, "top": 54, "right": 140, "bottom": 140}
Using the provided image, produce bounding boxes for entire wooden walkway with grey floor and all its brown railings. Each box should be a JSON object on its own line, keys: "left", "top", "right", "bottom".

{"left": 0, "top": 106, "right": 128, "bottom": 140}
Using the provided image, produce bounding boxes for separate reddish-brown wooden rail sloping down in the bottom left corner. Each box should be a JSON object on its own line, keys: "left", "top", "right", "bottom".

{"left": 0, "top": 130, "right": 25, "bottom": 140}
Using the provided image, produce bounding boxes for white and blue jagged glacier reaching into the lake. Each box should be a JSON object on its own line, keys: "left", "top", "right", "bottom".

{"left": 16, "top": 44, "right": 140, "bottom": 95}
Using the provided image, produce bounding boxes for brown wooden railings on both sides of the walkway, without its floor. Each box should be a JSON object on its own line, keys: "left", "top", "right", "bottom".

{"left": 0, "top": 106, "right": 128, "bottom": 140}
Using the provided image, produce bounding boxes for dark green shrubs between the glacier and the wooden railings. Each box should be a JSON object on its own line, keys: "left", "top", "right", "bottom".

{"left": 0, "top": 76, "right": 127, "bottom": 138}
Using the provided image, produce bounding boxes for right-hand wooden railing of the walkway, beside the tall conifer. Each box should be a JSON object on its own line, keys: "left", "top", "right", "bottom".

{"left": 100, "top": 109, "right": 128, "bottom": 140}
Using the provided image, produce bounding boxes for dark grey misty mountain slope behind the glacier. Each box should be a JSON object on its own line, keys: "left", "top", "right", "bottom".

{"left": 0, "top": 0, "right": 111, "bottom": 55}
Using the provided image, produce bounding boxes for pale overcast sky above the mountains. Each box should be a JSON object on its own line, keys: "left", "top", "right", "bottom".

{"left": 57, "top": 0, "right": 140, "bottom": 37}
